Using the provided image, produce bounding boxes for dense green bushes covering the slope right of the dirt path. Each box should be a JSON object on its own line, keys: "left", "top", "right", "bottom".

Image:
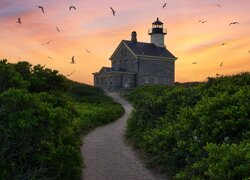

{"left": 126, "top": 73, "right": 250, "bottom": 179}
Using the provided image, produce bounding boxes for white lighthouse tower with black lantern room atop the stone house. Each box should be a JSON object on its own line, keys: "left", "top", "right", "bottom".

{"left": 148, "top": 18, "right": 167, "bottom": 48}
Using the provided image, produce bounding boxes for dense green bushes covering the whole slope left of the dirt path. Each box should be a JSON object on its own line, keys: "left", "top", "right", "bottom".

{"left": 0, "top": 60, "right": 123, "bottom": 179}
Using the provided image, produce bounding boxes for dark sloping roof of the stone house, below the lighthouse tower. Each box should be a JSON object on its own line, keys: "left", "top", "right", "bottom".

{"left": 123, "top": 40, "right": 177, "bottom": 59}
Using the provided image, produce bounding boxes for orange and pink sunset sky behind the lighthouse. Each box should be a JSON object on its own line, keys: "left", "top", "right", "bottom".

{"left": 0, "top": 0, "right": 250, "bottom": 84}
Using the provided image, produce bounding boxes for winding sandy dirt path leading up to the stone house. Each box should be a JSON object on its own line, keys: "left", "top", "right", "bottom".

{"left": 81, "top": 93, "right": 164, "bottom": 180}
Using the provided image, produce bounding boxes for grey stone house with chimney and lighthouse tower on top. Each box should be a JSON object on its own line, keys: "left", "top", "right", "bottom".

{"left": 93, "top": 18, "right": 177, "bottom": 91}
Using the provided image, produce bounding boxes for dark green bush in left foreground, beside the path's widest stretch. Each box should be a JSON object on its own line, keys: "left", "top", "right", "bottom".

{"left": 0, "top": 89, "right": 81, "bottom": 179}
